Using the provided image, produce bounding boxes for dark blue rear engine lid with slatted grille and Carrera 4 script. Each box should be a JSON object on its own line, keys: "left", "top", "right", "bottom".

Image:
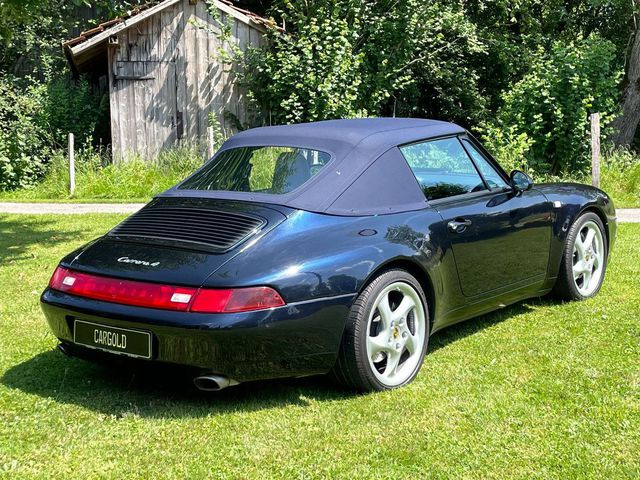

{"left": 61, "top": 198, "right": 290, "bottom": 286}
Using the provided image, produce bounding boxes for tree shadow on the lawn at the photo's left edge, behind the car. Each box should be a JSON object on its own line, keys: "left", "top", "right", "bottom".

{"left": 0, "top": 215, "right": 87, "bottom": 264}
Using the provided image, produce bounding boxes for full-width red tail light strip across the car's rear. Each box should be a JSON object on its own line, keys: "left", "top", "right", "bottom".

{"left": 49, "top": 267, "right": 285, "bottom": 313}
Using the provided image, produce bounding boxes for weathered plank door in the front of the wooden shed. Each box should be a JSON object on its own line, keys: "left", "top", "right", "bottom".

{"left": 112, "top": 61, "right": 183, "bottom": 160}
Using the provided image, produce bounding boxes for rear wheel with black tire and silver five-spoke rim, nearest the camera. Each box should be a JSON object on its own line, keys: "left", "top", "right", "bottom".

{"left": 331, "top": 269, "right": 429, "bottom": 392}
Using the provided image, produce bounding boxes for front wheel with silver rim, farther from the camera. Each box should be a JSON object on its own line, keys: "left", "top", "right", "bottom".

{"left": 553, "top": 212, "right": 608, "bottom": 300}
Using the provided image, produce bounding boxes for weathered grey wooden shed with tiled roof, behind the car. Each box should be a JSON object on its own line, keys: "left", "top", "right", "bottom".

{"left": 63, "top": 0, "right": 268, "bottom": 160}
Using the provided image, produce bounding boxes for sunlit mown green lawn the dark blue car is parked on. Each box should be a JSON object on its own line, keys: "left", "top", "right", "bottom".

{"left": 0, "top": 215, "right": 640, "bottom": 479}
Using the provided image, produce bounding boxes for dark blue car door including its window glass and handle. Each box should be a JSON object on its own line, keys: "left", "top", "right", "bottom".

{"left": 401, "top": 137, "right": 551, "bottom": 297}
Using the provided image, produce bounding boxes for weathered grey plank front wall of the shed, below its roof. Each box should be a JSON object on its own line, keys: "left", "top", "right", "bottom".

{"left": 108, "top": 0, "right": 263, "bottom": 159}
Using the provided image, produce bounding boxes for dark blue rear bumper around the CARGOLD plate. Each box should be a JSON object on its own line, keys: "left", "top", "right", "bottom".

{"left": 41, "top": 289, "right": 355, "bottom": 382}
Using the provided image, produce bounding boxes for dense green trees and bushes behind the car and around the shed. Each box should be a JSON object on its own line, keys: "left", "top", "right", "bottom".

{"left": 0, "top": 0, "right": 638, "bottom": 193}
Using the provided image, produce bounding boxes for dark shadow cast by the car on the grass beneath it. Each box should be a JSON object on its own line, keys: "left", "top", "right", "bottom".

{"left": 1, "top": 299, "right": 549, "bottom": 418}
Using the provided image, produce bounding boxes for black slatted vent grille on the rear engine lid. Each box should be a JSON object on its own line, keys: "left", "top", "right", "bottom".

{"left": 109, "top": 202, "right": 266, "bottom": 252}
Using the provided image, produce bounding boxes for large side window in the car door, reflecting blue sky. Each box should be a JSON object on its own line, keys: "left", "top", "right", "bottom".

{"left": 400, "top": 138, "right": 486, "bottom": 200}
